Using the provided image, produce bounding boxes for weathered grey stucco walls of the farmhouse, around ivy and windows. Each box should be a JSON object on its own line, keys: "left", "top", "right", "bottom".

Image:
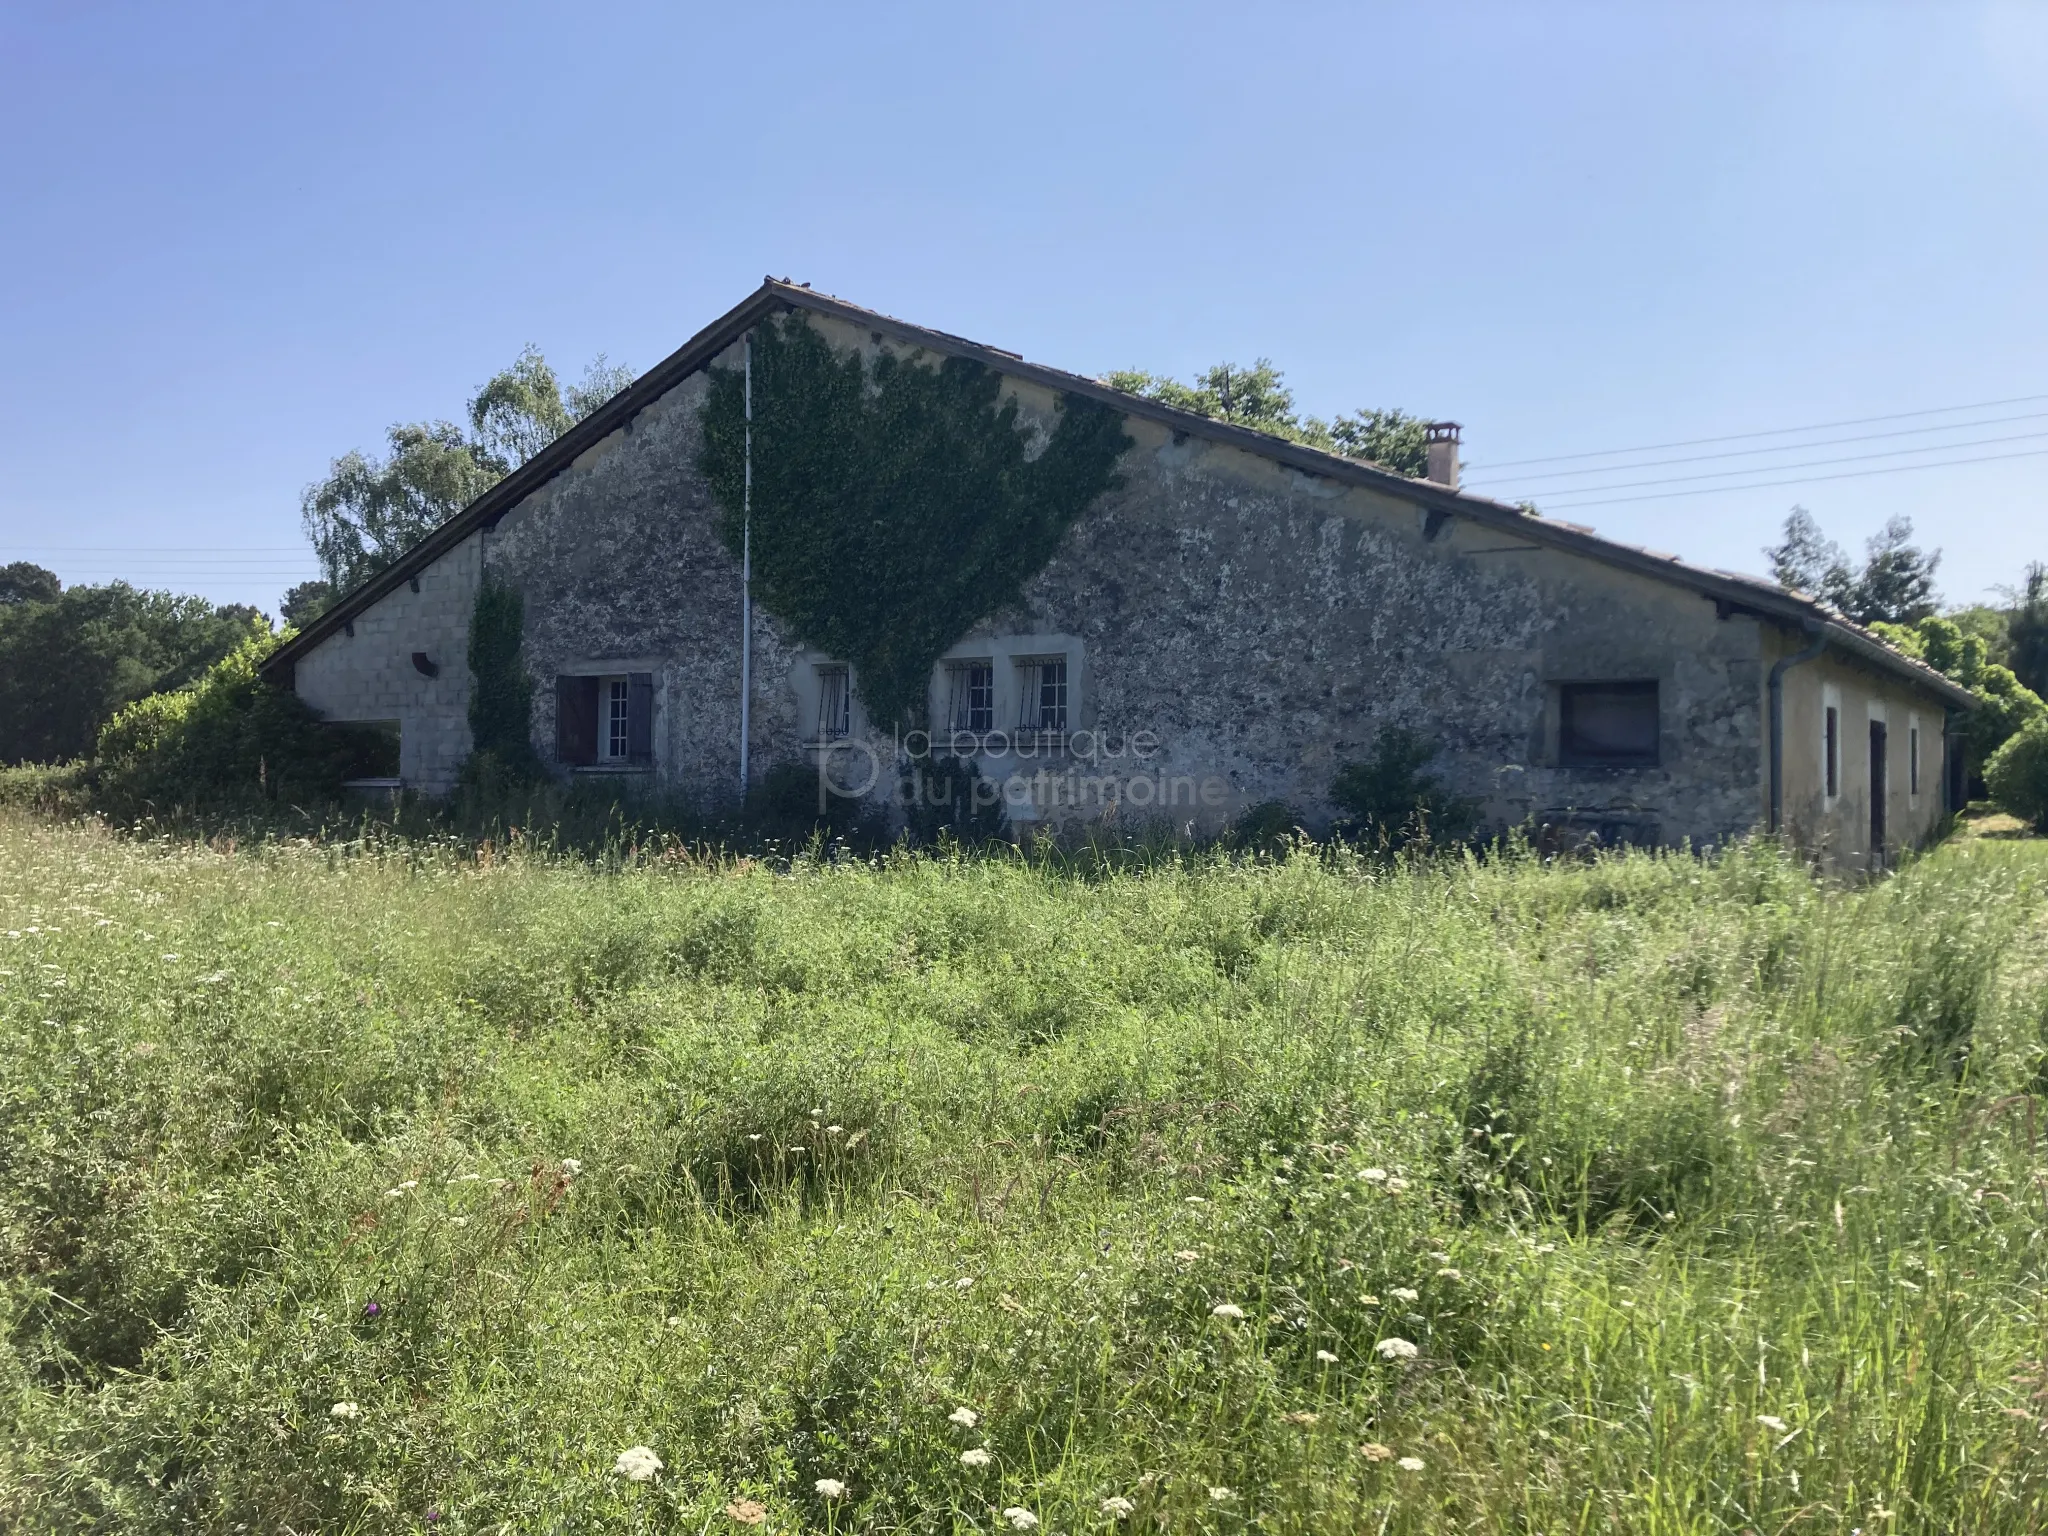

{"left": 284, "top": 317, "right": 1939, "bottom": 868}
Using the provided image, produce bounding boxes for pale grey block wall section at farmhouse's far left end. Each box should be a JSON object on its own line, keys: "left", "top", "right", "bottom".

{"left": 293, "top": 537, "right": 479, "bottom": 795}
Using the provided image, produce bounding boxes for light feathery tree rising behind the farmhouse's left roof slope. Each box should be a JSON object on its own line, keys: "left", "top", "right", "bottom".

{"left": 295, "top": 346, "right": 633, "bottom": 600}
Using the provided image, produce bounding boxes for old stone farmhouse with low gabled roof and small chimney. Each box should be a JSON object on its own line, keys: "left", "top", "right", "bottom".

{"left": 268, "top": 281, "right": 1970, "bottom": 866}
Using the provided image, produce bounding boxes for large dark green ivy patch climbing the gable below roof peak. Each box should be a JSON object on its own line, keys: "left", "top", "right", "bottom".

{"left": 698, "top": 315, "right": 1130, "bottom": 725}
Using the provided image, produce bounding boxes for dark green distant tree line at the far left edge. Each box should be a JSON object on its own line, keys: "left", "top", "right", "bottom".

{"left": 0, "top": 581, "right": 268, "bottom": 762}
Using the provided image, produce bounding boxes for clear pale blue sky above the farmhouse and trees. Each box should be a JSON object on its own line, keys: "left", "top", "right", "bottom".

{"left": 0, "top": 0, "right": 2048, "bottom": 608}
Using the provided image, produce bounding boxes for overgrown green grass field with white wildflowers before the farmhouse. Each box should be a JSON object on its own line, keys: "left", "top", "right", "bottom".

{"left": 0, "top": 817, "right": 2048, "bottom": 1536}
